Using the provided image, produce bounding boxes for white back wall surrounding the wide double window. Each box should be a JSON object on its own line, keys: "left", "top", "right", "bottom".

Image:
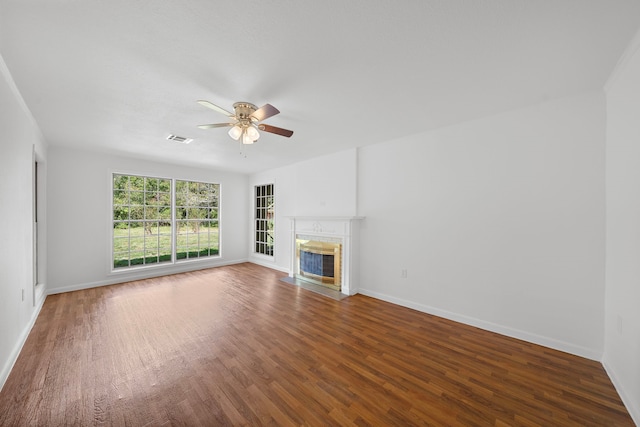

{"left": 48, "top": 147, "right": 250, "bottom": 293}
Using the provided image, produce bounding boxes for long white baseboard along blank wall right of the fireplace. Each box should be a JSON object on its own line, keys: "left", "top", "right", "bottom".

{"left": 359, "top": 288, "right": 602, "bottom": 362}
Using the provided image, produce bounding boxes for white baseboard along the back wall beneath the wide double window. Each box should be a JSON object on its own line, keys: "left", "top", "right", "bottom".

{"left": 48, "top": 259, "right": 248, "bottom": 295}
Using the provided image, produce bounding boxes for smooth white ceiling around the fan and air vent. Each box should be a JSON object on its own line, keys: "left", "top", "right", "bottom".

{"left": 0, "top": 0, "right": 640, "bottom": 173}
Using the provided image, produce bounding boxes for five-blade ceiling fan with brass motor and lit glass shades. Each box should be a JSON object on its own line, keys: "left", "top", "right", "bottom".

{"left": 198, "top": 100, "right": 293, "bottom": 144}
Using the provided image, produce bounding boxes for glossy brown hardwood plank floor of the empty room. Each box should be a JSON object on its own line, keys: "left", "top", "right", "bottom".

{"left": 0, "top": 264, "right": 633, "bottom": 426}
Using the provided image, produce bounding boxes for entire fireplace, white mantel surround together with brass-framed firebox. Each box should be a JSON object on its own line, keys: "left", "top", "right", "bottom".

{"left": 289, "top": 216, "right": 364, "bottom": 295}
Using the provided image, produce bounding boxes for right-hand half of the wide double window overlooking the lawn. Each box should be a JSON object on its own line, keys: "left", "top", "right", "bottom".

{"left": 176, "top": 181, "right": 220, "bottom": 259}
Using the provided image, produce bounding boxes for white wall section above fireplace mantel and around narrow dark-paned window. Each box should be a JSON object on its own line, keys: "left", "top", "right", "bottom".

{"left": 248, "top": 149, "right": 357, "bottom": 272}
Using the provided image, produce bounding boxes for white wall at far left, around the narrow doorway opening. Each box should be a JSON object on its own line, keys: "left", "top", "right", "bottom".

{"left": 0, "top": 57, "right": 46, "bottom": 388}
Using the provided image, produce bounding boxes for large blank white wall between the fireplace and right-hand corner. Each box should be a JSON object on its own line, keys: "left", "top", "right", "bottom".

{"left": 358, "top": 92, "right": 605, "bottom": 360}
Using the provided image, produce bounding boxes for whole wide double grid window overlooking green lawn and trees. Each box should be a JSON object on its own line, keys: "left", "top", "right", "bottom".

{"left": 113, "top": 174, "right": 219, "bottom": 269}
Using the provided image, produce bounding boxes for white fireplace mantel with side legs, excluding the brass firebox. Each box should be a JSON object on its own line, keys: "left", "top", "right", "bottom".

{"left": 288, "top": 216, "right": 364, "bottom": 295}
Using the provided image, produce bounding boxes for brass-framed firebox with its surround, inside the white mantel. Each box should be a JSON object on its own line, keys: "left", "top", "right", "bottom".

{"left": 296, "top": 238, "right": 342, "bottom": 291}
